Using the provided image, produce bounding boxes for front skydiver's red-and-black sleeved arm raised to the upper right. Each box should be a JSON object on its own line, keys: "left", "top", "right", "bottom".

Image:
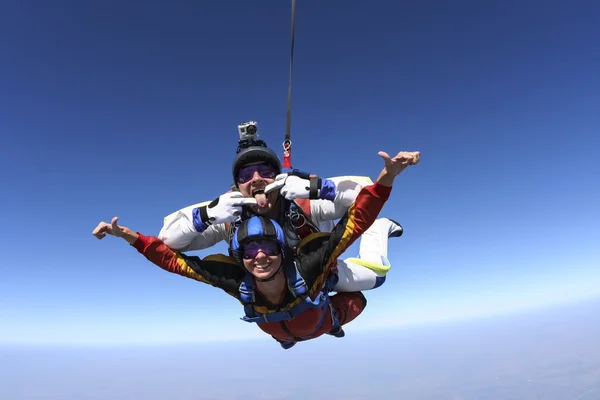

{"left": 300, "top": 152, "right": 420, "bottom": 294}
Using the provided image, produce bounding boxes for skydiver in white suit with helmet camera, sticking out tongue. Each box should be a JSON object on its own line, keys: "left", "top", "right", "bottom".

{"left": 158, "top": 121, "right": 403, "bottom": 292}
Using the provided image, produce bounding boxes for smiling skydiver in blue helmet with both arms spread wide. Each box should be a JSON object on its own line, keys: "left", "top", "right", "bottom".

{"left": 93, "top": 148, "right": 420, "bottom": 349}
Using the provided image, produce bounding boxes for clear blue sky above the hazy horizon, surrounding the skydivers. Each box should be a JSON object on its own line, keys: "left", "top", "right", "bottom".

{"left": 0, "top": 1, "right": 600, "bottom": 343}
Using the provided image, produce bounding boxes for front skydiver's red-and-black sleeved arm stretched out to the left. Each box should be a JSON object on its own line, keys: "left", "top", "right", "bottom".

{"left": 92, "top": 217, "right": 244, "bottom": 298}
